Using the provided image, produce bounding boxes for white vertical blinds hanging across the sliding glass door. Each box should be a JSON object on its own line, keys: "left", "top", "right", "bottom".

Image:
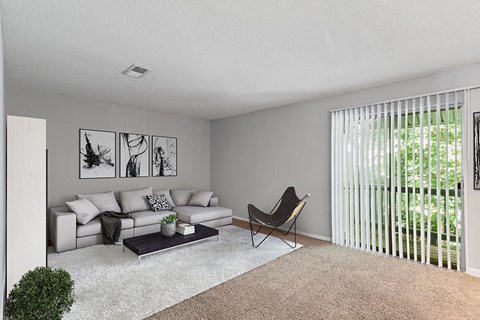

{"left": 331, "top": 90, "right": 466, "bottom": 270}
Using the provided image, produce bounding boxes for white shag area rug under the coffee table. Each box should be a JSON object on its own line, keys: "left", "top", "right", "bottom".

{"left": 48, "top": 226, "right": 301, "bottom": 320}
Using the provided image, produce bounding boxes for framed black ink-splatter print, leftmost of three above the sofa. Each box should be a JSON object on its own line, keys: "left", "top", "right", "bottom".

{"left": 79, "top": 129, "right": 116, "bottom": 179}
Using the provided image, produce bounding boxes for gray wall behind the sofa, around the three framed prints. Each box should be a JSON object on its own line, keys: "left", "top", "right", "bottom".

{"left": 5, "top": 87, "right": 210, "bottom": 207}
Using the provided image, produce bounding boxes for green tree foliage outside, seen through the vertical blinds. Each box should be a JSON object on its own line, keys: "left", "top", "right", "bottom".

{"left": 369, "top": 108, "right": 462, "bottom": 239}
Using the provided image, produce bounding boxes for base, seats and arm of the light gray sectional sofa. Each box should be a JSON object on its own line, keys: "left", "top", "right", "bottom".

{"left": 48, "top": 190, "right": 232, "bottom": 252}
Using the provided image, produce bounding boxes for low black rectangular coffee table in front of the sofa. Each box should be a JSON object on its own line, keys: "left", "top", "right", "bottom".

{"left": 123, "top": 224, "right": 218, "bottom": 260}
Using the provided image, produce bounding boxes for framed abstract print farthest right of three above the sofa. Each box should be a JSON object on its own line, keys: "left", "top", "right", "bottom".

{"left": 152, "top": 136, "right": 177, "bottom": 177}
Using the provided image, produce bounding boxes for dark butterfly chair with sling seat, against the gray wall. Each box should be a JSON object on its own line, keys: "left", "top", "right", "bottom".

{"left": 248, "top": 187, "right": 310, "bottom": 249}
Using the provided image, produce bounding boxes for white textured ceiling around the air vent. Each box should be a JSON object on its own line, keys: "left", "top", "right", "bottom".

{"left": 1, "top": 0, "right": 480, "bottom": 119}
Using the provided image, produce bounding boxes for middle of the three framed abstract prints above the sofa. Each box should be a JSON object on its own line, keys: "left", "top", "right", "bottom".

{"left": 120, "top": 133, "right": 150, "bottom": 178}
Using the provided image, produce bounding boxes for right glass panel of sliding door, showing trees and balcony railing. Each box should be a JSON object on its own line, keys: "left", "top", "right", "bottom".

{"left": 391, "top": 102, "right": 462, "bottom": 269}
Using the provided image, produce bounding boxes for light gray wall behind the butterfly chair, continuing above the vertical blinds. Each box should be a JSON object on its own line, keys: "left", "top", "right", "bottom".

{"left": 211, "top": 64, "right": 480, "bottom": 270}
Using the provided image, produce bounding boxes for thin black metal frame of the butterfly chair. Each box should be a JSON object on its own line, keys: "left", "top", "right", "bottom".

{"left": 248, "top": 194, "right": 310, "bottom": 249}
